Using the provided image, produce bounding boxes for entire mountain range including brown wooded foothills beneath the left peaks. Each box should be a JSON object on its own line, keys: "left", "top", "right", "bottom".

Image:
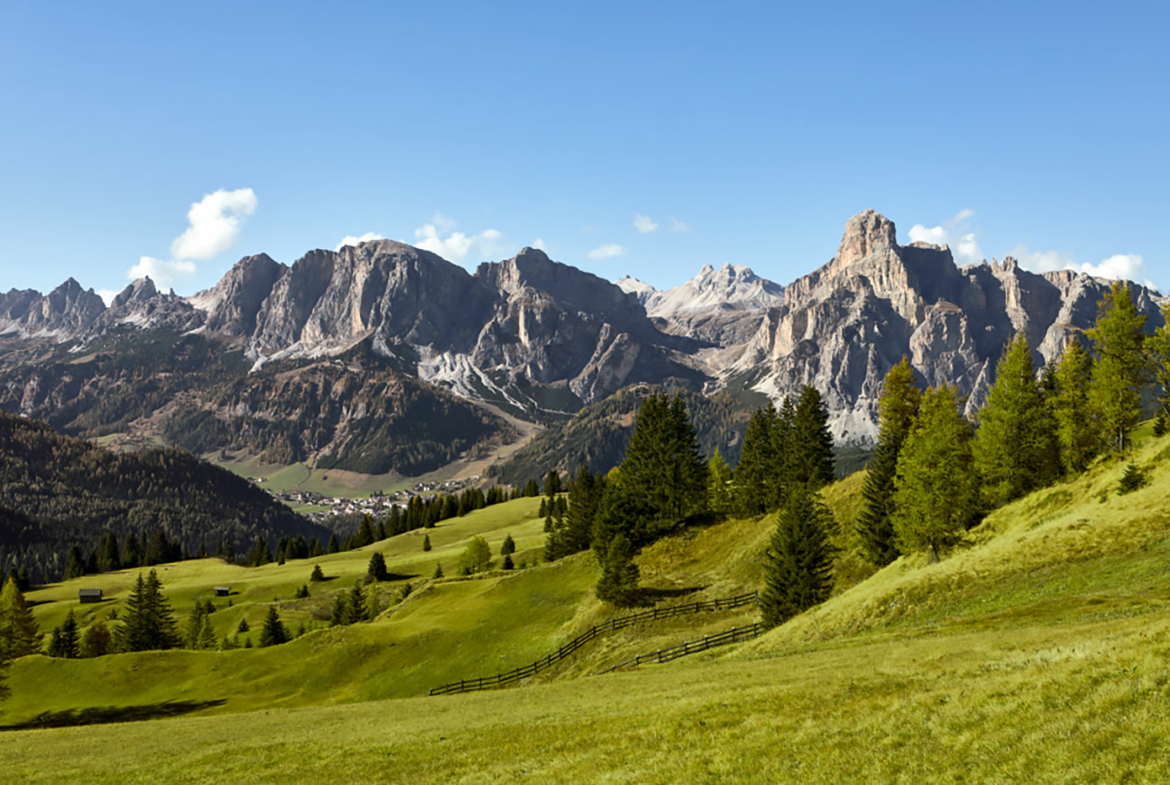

{"left": 0, "top": 211, "right": 1165, "bottom": 471}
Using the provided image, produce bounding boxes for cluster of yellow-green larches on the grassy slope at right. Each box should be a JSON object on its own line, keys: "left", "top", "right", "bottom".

{"left": 858, "top": 282, "right": 1170, "bottom": 565}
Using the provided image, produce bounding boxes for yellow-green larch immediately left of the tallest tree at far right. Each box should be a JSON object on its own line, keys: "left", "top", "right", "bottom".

{"left": 1052, "top": 336, "right": 1101, "bottom": 475}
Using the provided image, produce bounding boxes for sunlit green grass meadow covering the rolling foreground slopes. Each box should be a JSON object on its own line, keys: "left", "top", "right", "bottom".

{"left": 0, "top": 435, "right": 1170, "bottom": 783}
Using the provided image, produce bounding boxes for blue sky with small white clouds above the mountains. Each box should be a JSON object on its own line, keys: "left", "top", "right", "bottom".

{"left": 0, "top": 1, "right": 1170, "bottom": 294}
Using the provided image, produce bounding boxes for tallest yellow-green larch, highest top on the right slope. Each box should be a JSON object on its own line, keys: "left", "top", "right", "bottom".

{"left": 1087, "top": 281, "right": 1149, "bottom": 453}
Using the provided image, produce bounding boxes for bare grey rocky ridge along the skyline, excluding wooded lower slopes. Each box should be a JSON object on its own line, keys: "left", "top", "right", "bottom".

{"left": 0, "top": 211, "right": 1162, "bottom": 453}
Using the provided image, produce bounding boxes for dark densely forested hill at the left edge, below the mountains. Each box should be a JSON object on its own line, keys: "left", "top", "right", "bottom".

{"left": 0, "top": 412, "right": 324, "bottom": 584}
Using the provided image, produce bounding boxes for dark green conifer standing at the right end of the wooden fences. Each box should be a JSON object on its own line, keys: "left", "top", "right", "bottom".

{"left": 759, "top": 484, "right": 833, "bottom": 627}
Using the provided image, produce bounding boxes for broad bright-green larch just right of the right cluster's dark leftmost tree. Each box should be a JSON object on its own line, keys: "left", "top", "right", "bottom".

{"left": 892, "top": 386, "right": 979, "bottom": 560}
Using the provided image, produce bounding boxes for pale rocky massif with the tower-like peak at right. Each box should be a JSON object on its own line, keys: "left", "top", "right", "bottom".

{"left": 725, "top": 211, "right": 1162, "bottom": 441}
